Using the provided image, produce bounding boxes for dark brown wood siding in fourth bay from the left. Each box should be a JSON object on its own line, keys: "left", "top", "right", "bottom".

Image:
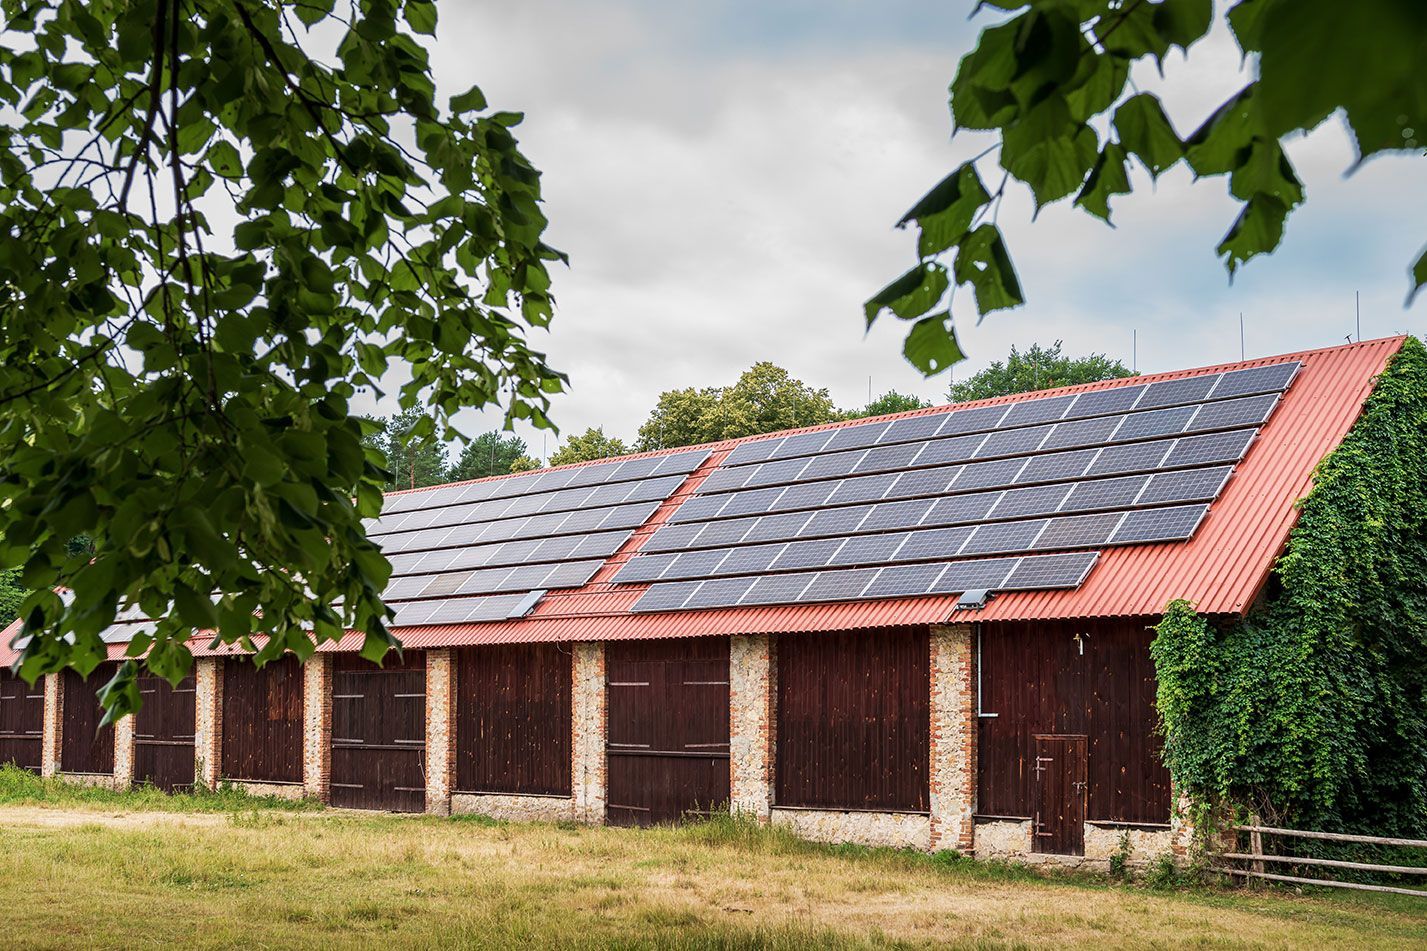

{"left": 221, "top": 657, "right": 303, "bottom": 783}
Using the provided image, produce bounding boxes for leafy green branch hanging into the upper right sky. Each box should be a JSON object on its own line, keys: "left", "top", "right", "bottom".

{"left": 865, "top": 0, "right": 1427, "bottom": 376}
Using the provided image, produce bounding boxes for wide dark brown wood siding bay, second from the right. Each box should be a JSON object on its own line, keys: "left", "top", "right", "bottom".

{"left": 773, "top": 628, "right": 932, "bottom": 811}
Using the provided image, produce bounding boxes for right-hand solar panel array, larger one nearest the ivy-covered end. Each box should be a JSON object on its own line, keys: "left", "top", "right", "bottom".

{"left": 615, "top": 363, "right": 1299, "bottom": 611}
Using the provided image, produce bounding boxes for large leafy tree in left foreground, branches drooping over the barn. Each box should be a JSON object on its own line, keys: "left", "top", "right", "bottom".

{"left": 0, "top": 0, "right": 565, "bottom": 718}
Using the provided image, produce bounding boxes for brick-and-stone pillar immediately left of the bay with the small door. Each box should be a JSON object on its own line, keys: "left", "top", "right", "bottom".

{"left": 930, "top": 624, "right": 976, "bottom": 852}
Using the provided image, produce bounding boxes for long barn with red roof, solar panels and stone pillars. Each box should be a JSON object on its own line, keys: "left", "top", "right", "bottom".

{"left": 0, "top": 337, "right": 1404, "bottom": 861}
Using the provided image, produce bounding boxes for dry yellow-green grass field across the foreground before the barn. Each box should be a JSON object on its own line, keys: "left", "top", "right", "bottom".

{"left": 0, "top": 775, "right": 1427, "bottom": 948}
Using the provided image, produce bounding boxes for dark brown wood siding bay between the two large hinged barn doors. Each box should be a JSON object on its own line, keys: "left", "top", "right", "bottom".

{"left": 454, "top": 644, "right": 572, "bottom": 795}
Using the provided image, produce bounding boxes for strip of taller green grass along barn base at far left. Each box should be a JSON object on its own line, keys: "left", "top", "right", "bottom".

{"left": 0, "top": 763, "right": 321, "bottom": 812}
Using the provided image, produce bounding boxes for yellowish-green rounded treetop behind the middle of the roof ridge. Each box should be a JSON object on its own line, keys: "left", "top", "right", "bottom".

{"left": 635, "top": 361, "right": 839, "bottom": 451}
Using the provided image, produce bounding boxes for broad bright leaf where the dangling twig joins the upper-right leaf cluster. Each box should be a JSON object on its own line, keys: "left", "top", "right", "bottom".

{"left": 1000, "top": 99, "right": 1099, "bottom": 210}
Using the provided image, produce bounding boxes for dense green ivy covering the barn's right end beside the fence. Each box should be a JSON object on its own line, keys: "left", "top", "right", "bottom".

{"left": 1152, "top": 338, "right": 1427, "bottom": 838}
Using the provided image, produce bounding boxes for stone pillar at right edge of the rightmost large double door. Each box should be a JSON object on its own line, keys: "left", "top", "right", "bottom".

{"left": 728, "top": 634, "right": 775, "bottom": 822}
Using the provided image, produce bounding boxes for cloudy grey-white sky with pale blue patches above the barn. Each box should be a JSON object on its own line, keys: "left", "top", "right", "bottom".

{"left": 410, "top": 0, "right": 1427, "bottom": 454}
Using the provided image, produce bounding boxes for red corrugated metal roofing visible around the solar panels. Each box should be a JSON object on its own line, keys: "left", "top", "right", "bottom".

{"left": 7, "top": 337, "right": 1404, "bottom": 657}
